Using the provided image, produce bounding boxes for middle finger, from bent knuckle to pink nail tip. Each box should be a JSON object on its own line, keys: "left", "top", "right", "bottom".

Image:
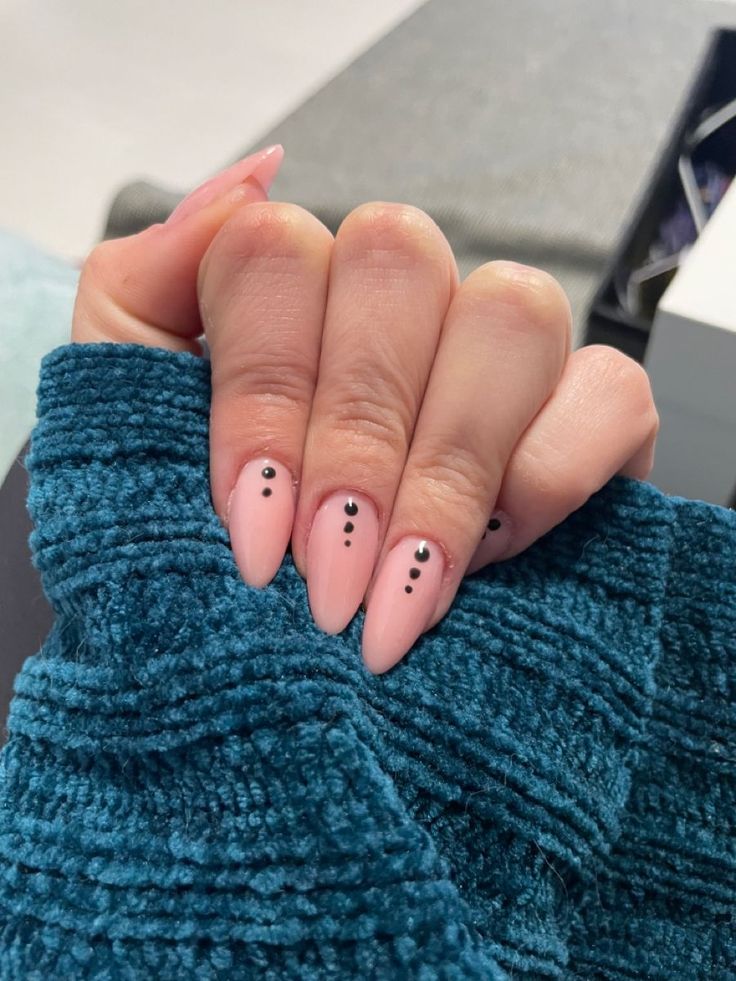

{"left": 292, "top": 202, "right": 457, "bottom": 633}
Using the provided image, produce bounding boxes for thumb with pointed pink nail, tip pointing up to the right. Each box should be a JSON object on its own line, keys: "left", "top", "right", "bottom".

{"left": 72, "top": 146, "right": 283, "bottom": 353}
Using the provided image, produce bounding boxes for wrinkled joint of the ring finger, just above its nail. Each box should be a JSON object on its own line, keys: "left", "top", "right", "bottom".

{"left": 412, "top": 446, "right": 494, "bottom": 511}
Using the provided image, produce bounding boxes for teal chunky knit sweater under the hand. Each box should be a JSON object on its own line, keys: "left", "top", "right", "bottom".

{"left": 0, "top": 345, "right": 736, "bottom": 981}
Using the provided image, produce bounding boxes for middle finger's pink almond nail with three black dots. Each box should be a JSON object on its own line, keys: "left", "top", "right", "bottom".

{"left": 307, "top": 491, "right": 378, "bottom": 634}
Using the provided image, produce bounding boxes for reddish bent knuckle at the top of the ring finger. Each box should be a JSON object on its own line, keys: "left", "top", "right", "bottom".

{"left": 459, "top": 260, "right": 572, "bottom": 341}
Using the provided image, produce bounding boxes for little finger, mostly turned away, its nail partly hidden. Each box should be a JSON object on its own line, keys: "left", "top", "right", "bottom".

{"left": 466, "top": 344, "right": 659, "bottom": 575}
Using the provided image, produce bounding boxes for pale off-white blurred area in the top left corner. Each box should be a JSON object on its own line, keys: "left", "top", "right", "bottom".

{"left": 0, "top": 0, "right": 421, "bottom": 258}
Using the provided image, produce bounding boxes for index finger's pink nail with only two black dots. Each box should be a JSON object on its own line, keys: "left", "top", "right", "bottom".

{"left": 228, "top": 457, "right": 295, "bottom": 588}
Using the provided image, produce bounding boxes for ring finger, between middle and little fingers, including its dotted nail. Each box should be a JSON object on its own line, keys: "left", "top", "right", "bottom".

{"left": 363, "top": 262, "right": 571, "bottom": 672}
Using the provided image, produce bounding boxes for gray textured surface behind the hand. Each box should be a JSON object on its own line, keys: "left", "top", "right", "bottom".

{"left": 108, "top": 0, "right": 736, "bottom": 341}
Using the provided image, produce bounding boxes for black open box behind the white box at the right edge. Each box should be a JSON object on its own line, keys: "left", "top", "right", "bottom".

{"left": 584, "top": 30, "right": 736, "bottom": 362}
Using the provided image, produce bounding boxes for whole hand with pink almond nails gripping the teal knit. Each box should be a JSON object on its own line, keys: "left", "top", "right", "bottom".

{"left": 73, "top": 147, "right": 658, "bottom": 672}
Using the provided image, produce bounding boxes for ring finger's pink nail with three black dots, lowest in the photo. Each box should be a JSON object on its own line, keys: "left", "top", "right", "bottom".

{"left": 363, "top": 535, "right": 445, "bottom": 674}
